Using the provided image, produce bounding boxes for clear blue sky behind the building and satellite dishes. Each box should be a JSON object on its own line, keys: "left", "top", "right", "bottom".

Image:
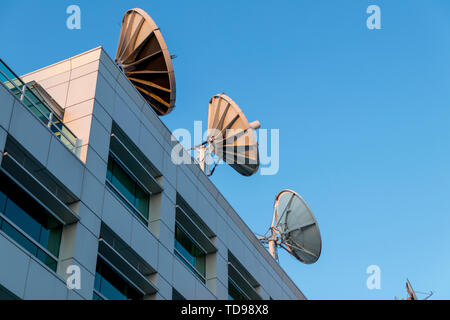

{"left": 0, "top": 0, "right": 450, "bottom": 299}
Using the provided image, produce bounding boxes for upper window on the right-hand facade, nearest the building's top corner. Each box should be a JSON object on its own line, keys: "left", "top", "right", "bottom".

{"left": 106, "top": 154, "right": 150, "bottom": 225}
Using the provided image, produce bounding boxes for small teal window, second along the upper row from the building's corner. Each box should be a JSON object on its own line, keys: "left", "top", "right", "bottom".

{"left": 175, "top": 224, "right": 206, "bottom": 283}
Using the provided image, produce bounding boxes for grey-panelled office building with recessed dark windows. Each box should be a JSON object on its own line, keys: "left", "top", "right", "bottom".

{"left": 0, "top": 47, "right": 305, "bottom": 300}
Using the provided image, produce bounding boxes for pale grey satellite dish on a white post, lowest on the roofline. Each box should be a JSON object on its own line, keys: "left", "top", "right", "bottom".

{"left": 260, "top": 190, "right": 322, "bottom": 264}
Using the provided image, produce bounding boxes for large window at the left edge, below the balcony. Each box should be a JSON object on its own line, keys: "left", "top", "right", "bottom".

{"left": 0, "top": 175, "right": 63, "bottom": 271}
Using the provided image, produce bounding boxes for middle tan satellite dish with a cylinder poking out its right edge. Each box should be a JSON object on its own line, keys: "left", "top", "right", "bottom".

{"left": 193, "top": 93, "right": 261, "bottom": 177}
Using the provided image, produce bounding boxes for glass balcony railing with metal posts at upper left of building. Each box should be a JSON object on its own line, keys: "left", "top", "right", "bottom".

{"left": 0, "top": 59, "right": 81, "bottom": 157}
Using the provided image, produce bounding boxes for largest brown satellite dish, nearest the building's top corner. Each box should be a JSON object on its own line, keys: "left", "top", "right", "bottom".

{"left": 116, "top": 8, "right": 176, "bottom": 116}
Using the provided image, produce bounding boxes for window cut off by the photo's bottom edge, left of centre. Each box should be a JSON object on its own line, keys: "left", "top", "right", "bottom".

{"left": 92, "top": 258, "right": 143, "bottom": 300}
